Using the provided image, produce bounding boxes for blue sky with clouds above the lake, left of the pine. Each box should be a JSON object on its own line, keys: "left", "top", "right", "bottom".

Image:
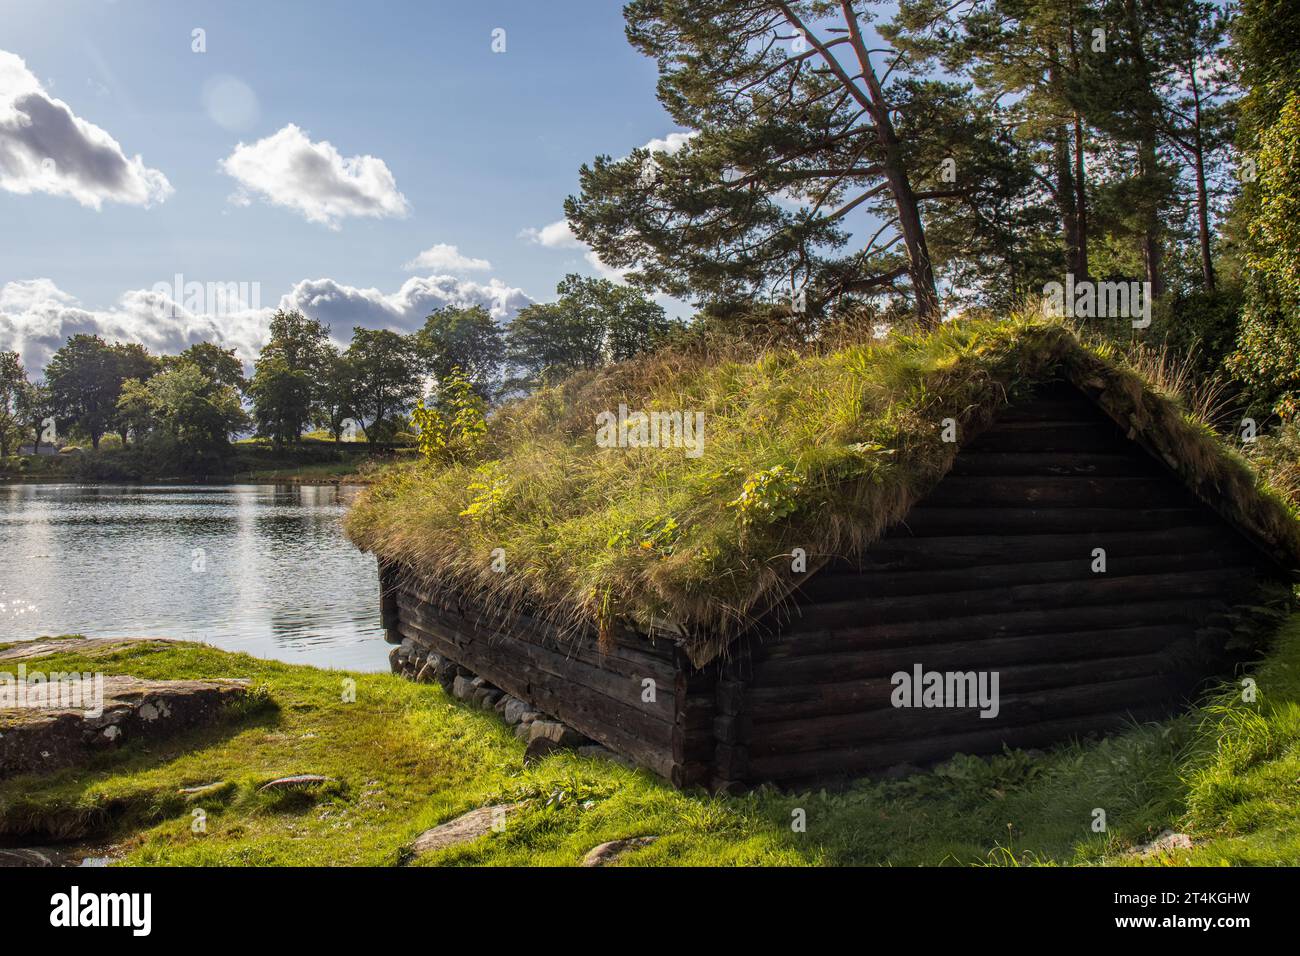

{"left": 0, "top": 0, "right": 691, "bottom": 365}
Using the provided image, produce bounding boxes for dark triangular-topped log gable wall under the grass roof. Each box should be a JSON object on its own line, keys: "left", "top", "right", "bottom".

{"left": 714, "top": 384, "right": 1268, "bottom": 787}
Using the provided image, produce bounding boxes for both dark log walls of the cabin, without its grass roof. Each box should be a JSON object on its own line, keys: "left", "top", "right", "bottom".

{"left": 366, "top": 376, "right": 1300, "bottom": 791}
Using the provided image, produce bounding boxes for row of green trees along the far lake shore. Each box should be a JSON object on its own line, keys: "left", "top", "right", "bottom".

{"left": 0, "top": 274, "right": 680, "bottom": 464}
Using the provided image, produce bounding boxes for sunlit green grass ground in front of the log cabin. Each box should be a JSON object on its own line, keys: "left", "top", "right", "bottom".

{"left": 0, "top": 615, "right": 1300, "bottom": 865}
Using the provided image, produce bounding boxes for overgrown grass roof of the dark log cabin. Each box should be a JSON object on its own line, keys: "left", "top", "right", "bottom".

{"left": 346, "top": 317, "right": 1300, "bottom": 661}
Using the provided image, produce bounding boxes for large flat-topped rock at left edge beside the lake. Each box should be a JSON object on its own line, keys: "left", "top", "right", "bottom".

{"left": 0, "top": 675, "right": 248, "bottom": 779}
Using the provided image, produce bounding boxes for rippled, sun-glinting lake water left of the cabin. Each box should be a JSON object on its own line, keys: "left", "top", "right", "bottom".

{"left": 0, "top": 484, "right": 389, "bottom": 671}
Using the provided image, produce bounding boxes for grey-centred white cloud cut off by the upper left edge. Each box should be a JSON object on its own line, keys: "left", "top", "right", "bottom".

{"left": 0, "top": 49, "right": 173, "bottom": 209}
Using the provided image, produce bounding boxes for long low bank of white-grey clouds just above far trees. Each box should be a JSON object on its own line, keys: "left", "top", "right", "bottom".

{"left": 0, "top": 276, "right": 532, "bottom": 376}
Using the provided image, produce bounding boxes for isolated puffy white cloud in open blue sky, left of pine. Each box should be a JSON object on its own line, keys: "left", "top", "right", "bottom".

{"left": 221, "top": 124, "right": 410, "bottom": 229}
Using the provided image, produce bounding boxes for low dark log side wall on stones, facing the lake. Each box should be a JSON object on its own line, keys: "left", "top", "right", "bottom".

{"left": 381, "top": 567, "right": 714, "bottom": 787}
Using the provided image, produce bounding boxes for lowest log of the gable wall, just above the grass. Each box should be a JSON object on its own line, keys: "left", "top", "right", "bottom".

{"left": 746, "top": 701, "right": 1173, "bottom": 782}
